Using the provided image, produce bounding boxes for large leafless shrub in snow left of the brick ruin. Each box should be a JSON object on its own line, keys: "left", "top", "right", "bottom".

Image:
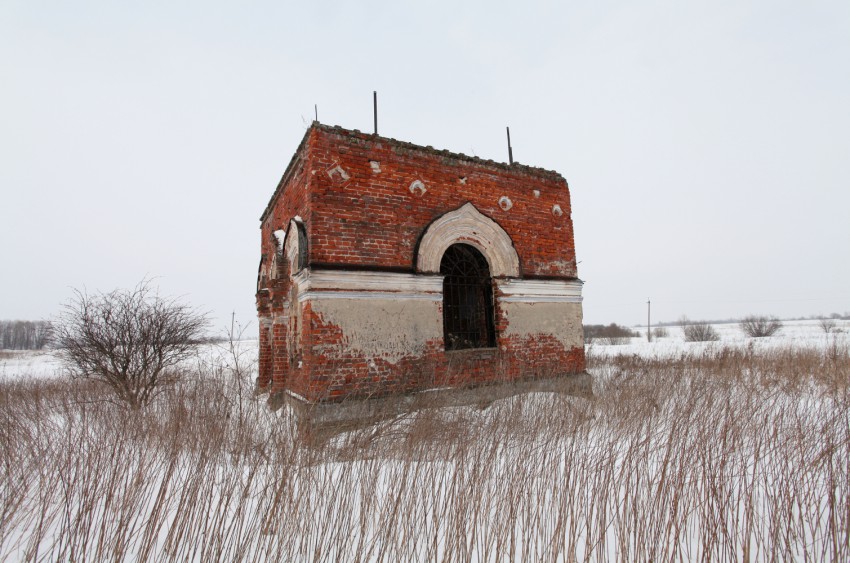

{"left": 55, "top": 280, "right": 208, "bottom": 409}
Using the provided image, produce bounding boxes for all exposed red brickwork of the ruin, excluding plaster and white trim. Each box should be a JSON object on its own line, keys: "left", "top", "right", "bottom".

{"left": 257, "top": 125, "right": 585, "bottom": 400}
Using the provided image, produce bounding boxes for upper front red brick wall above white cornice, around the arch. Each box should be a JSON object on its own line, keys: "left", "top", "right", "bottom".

{"left": 300, "top": 128, "right": 575, "bottom": 277}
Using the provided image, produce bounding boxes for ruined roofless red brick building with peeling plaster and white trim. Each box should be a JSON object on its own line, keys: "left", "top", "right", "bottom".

{"left": 257, "top": 123, "right": 585, "bottom": 402}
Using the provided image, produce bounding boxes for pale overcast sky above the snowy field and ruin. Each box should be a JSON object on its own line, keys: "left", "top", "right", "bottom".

{"left": 0, "top": 0, "right": 850, "bottom": 328}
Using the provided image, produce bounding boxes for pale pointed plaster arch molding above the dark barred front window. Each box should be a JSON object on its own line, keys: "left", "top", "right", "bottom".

{"left": 416, "top": 203, "right": 520, "bottom": 278}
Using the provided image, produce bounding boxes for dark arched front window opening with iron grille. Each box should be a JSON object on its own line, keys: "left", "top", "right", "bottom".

{"left": 440, "top": 244, "right": 496, "bottom": 350}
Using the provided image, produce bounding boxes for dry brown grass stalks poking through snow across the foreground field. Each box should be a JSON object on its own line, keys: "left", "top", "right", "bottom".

{"left": 0, "top": 344, "right": 850, "bottom": 561}
